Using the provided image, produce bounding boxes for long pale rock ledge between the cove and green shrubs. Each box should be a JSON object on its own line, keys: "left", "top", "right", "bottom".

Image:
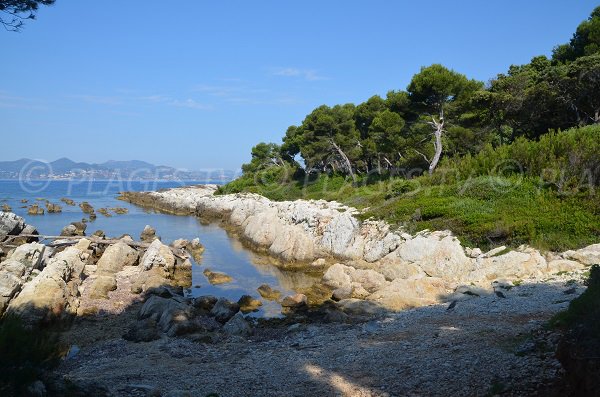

{"left": 120, "top": 185, "right": 600, "bottom": 310}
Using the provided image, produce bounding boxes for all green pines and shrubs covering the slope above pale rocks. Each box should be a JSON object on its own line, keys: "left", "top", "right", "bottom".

{"left": 220, "top": 7, "right": 600, "bottom": 250}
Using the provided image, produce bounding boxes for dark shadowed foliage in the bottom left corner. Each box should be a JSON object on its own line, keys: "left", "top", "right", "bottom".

{"left": 0, "top": 315, "right": 58, "bottom": 396}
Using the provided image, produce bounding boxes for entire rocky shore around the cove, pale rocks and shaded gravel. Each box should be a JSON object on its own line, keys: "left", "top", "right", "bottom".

{"left": 0, "top": 186, "right": 600, "bottom": 396}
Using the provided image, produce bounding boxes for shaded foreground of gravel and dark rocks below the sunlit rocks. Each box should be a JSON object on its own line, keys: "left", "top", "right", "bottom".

{"left": 2, "top": 272, "right": 584, "bottom": 396}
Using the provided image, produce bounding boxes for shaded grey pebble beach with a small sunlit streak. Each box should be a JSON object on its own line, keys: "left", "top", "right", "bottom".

{"left": 52, "top": 275, "right": 584, "bottom": 396}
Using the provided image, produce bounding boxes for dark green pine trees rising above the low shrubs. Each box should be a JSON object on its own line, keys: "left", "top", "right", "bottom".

{"left": 243, "top": 7, "right": 600, "bottom": 178}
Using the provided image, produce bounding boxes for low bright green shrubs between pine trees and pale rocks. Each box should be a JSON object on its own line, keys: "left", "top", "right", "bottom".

{"left": 220, "top": 126, "right": 600, "bottom": 251}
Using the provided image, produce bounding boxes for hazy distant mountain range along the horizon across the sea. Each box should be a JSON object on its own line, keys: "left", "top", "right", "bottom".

{"left": 0, "top": 157, "right": 235, "bottom": 182}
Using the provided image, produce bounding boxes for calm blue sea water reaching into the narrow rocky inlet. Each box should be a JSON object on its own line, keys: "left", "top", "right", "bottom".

{"left": 0, "top": 180, "right": 318, "bottom": 317}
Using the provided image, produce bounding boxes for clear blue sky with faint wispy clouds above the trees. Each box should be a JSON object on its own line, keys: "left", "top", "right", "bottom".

{"left": 0, "top": 0, "right": 597, "bottom": 169}
